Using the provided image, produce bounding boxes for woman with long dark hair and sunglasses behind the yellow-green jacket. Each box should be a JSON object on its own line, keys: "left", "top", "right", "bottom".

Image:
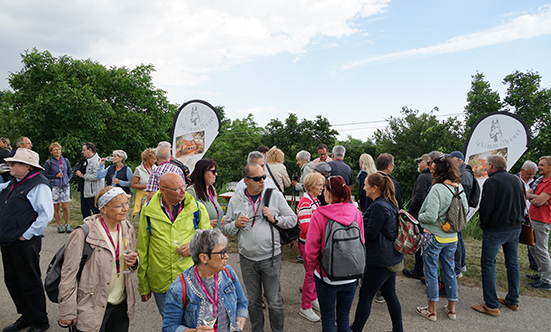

{"left": 187, "top": 159, "right": 224, "bottom": 228}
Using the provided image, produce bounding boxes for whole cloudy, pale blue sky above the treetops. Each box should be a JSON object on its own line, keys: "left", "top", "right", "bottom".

{"left": 0, "top": 0, "right": 551, "bottom": 140}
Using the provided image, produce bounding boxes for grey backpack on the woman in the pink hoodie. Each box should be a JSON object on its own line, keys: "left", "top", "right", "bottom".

{"left": 320, "top": 219, "right": 365, "bottom": 281}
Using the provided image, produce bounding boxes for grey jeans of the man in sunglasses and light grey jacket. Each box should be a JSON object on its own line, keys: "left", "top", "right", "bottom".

{"left": 239, "top": 254, "right": 285, "bottom": 332}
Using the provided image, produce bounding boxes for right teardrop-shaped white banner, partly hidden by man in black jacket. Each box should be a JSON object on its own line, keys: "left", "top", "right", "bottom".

{"left": 463, "top": 112, "right": 530, "bottom": 218}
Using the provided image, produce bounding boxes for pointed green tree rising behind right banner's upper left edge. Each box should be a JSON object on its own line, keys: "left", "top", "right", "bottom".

{"left": 465, "top": 73, "right": 503, "bottom": 129}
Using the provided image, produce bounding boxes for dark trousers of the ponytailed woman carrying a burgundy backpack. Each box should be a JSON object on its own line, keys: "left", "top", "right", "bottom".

{"left": 350, "top": 267, "right": 403, "bottom": 332}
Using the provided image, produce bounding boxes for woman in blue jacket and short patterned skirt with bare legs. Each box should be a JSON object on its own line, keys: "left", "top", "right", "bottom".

{"left": 42, "top": 142, "right": 73, "bottom": 233}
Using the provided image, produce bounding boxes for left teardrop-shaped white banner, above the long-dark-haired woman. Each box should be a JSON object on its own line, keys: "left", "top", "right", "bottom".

{"left": 171, "top": 99, "right": 221, "bottom": 172}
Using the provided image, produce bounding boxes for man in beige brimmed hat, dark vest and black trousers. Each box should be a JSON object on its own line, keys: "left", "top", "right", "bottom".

{"left": 0, "top": 148, "right": 54, "bottom": 332}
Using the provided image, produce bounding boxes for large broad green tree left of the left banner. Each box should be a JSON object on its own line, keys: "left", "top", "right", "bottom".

{"left": 8, "top": 49, "right": 176, "bottom": 162}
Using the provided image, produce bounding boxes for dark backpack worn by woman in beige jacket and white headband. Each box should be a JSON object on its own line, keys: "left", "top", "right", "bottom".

{"left": 44, "top": 224, "right": 93, "bottom": 303}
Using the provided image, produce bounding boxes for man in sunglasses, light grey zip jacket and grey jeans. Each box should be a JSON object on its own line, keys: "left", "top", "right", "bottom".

{"left": 222, "top": 163, "right": 297, "bottom": 332}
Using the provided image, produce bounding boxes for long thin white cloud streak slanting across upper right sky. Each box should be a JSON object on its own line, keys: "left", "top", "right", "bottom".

{"left": 341, "top": 5, "right": 551, "bottom": 70}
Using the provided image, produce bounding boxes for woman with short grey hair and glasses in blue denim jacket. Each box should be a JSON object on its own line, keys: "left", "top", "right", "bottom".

{"left": 163, "top": 229, "right": 248, "bottom": 332}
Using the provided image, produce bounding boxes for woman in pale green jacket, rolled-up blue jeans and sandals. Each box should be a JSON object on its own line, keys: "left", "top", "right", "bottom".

{"left": 416, "top": 155, "right": 469, "bottom": 322}
